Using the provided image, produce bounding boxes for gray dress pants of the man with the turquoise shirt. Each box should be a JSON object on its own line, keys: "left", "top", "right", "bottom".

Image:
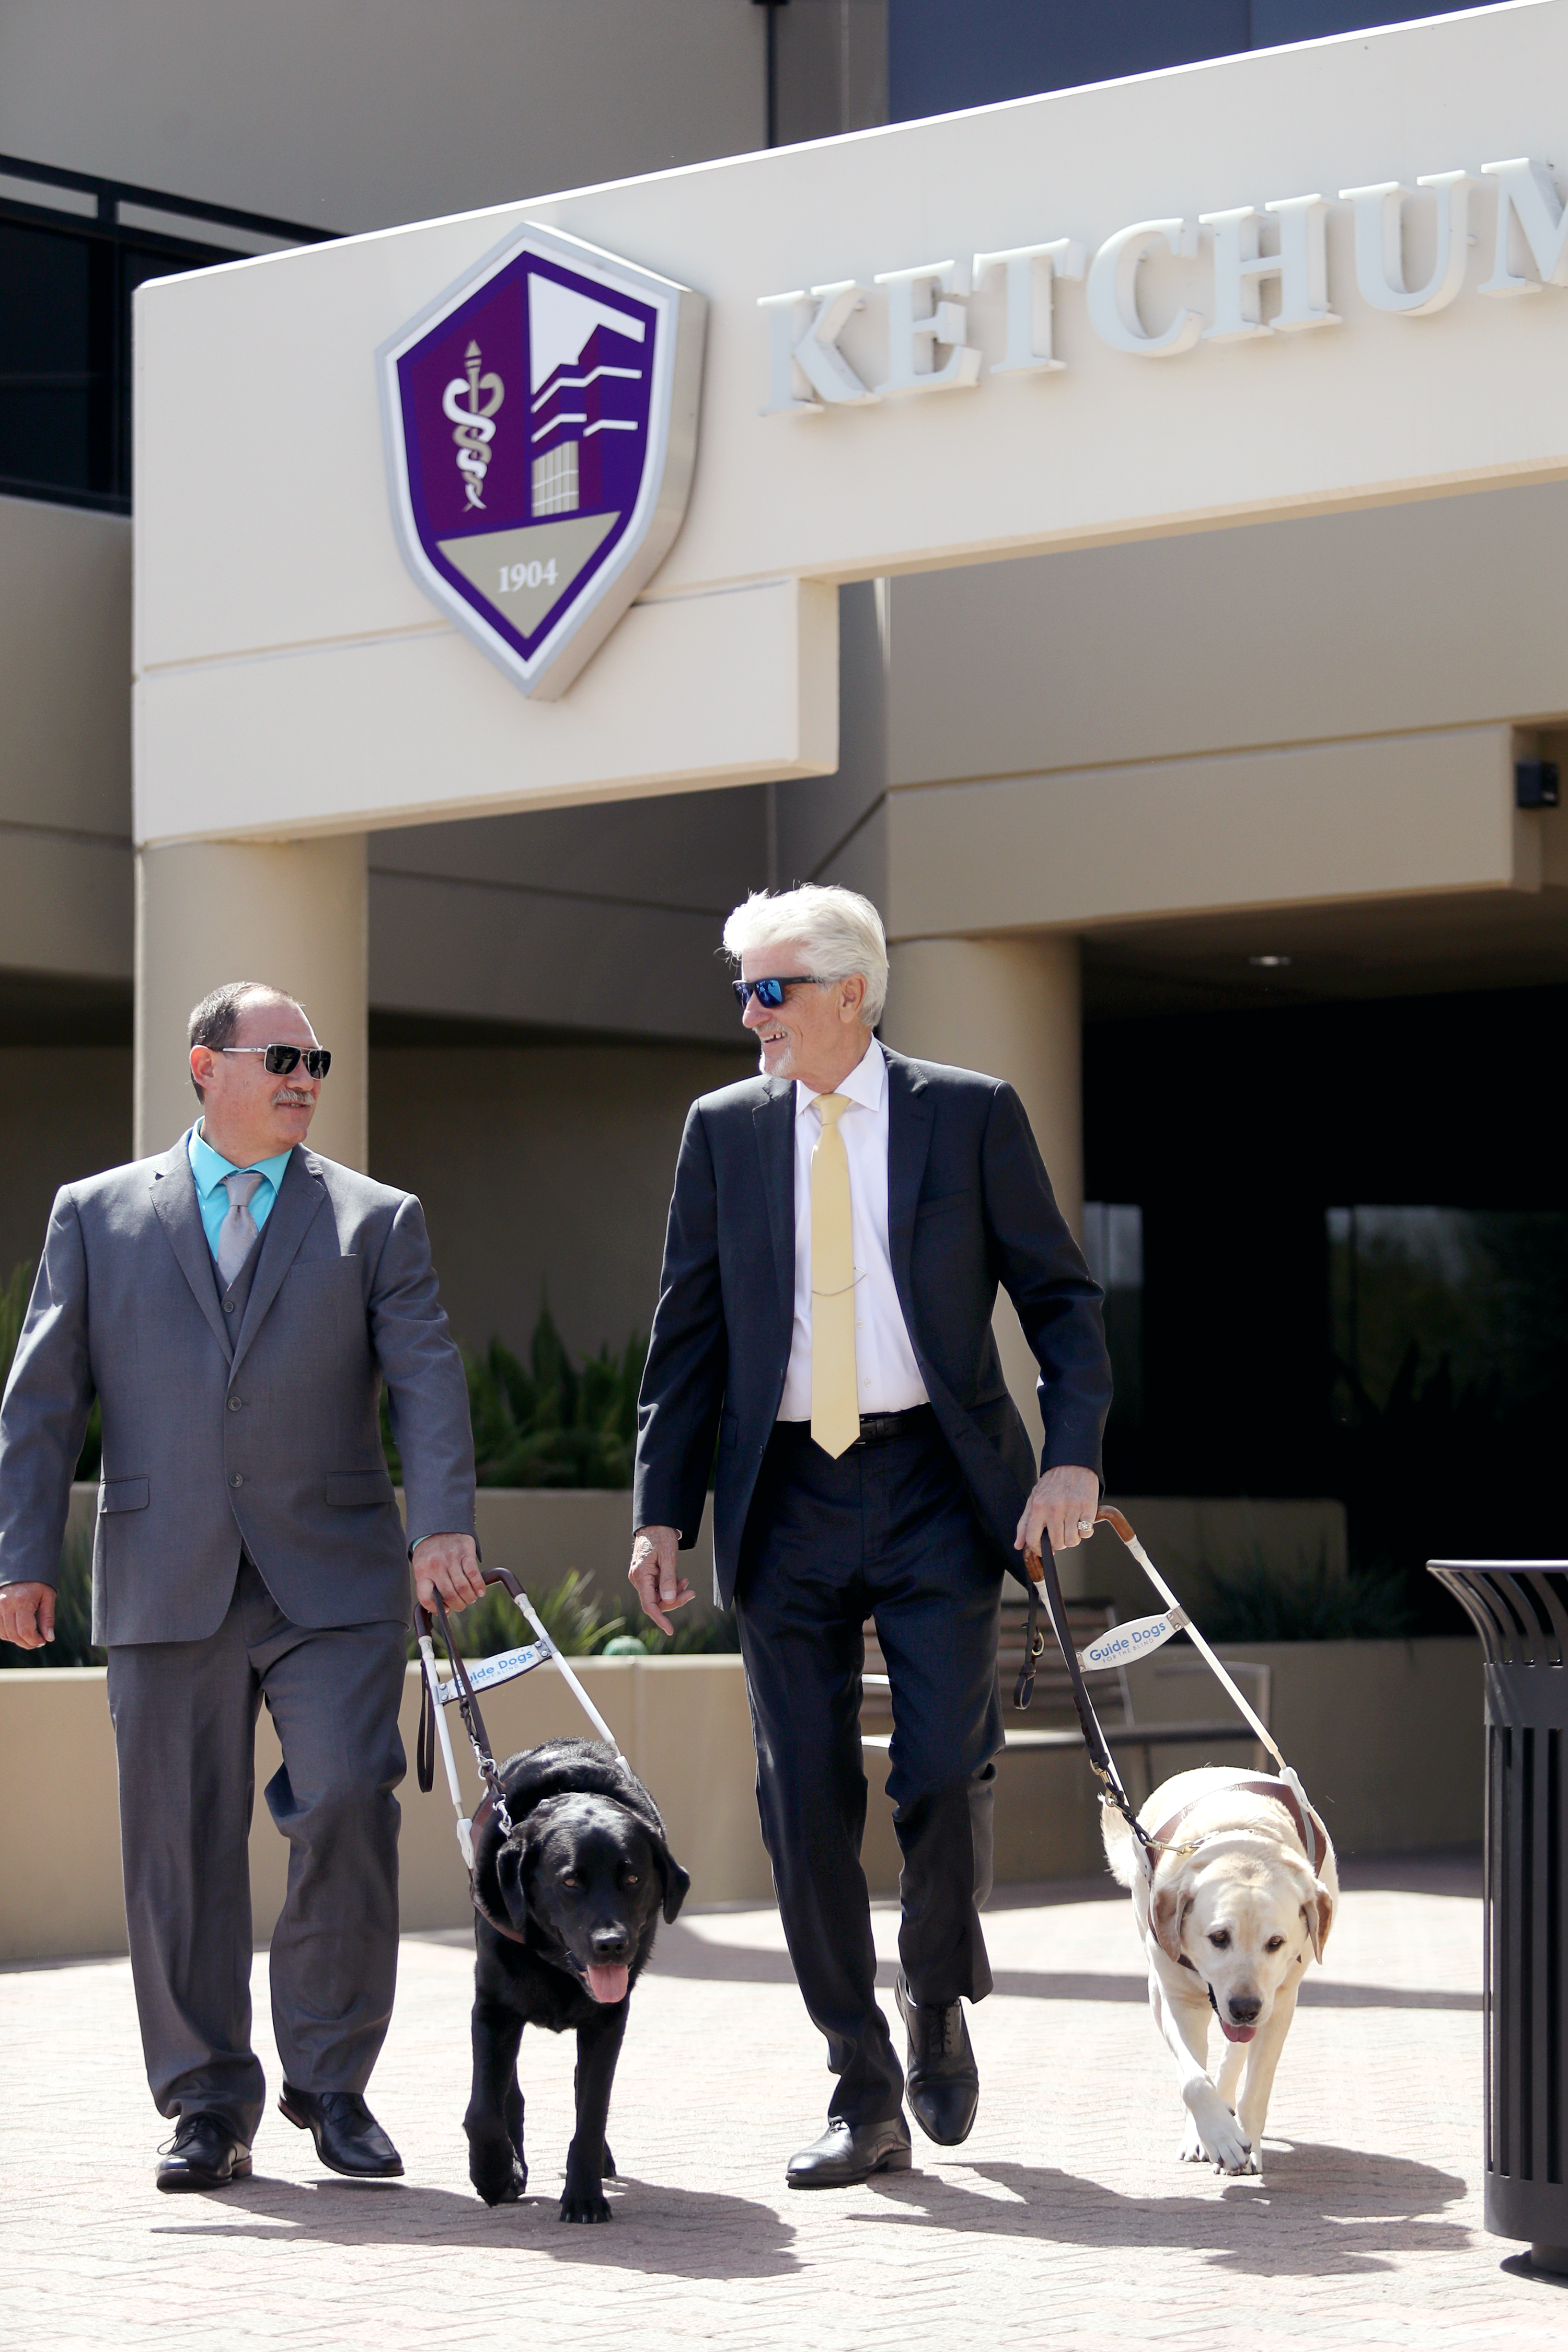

{"left": 108, "top": 1560, "right": 407, "bottom": 2145}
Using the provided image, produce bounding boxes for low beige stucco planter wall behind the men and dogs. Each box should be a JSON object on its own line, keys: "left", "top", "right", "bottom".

{"left": 0, "top": 1640, "right": 1483, "bottom": 1959}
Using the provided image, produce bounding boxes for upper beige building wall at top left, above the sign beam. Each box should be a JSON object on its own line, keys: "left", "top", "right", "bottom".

{"left": 0, "top": 0, "right": 766, "bottom": 230}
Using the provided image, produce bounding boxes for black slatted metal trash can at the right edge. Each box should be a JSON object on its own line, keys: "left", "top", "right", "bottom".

{"left": 1427, "top": 1560, "right": 1568, "bottom": 2272}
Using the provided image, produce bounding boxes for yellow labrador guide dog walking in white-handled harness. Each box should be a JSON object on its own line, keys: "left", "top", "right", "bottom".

{"left": 1102, "top": 1767, "right": 1340, "bottom": 2173}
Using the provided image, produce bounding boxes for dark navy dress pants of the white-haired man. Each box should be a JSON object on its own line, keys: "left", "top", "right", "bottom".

{"left": 736, "top": 1414, "right": 1001, "bottom": 2124}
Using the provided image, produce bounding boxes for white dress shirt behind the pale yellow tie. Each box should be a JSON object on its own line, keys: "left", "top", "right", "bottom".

{"left": 778, "top": 1037, "right": 931, "bottom": 1421}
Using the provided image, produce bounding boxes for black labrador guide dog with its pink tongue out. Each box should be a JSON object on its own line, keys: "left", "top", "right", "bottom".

{"left": 463, "top": 1740, "right": 691, "bottom": 2220}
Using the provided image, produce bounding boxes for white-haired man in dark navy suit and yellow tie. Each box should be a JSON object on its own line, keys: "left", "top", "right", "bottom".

{"left": 630, "top": 887, "right": 1110, "bottom": 2187}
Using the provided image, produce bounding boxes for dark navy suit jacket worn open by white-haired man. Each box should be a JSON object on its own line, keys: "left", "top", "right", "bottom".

{"left": 632, "top": 1052, "right": 1110, "bottom": 1607}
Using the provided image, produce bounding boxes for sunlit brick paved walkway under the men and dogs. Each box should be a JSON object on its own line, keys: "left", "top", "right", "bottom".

{"left": 0, "top": 1865, "right": 1568, "bottom": 2352}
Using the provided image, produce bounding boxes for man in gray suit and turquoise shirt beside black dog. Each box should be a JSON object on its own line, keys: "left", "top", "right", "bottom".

{"left": 0, "top": 983, "right": 485, "bottom": 2190}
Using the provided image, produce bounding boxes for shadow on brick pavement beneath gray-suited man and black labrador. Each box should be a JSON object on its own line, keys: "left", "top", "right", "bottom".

{"left": 153, "top": 2173, "right": 799, "bottom": 2279}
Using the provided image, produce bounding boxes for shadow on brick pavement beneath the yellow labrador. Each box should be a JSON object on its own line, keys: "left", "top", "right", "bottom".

{"left": 870, "top": 2143, "right": 1472, "bottom": 2277}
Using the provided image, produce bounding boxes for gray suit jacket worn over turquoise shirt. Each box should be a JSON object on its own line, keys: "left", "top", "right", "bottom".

{"left": 0, "top": 1136, "right": 475, "bottom": 1644}
